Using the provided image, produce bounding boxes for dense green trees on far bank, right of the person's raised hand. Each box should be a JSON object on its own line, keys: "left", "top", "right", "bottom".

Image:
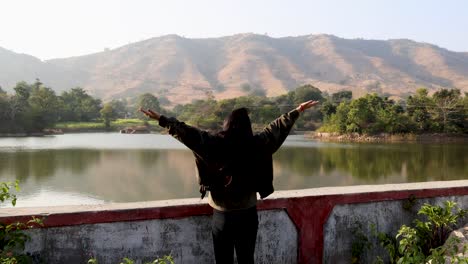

{"left": 320, "top": 88, "right": 468, "bottom": 134}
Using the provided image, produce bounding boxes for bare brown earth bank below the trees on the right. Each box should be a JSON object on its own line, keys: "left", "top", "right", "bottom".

{"left": 304, "top": 131, "right": 468, "bottom": 143}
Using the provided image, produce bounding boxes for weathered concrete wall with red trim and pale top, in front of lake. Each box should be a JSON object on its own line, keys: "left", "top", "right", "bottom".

{"left": 0, "top": 180, "right": 468, "bottom": 264}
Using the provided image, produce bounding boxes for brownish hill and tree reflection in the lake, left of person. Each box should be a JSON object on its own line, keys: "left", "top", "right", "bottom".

{"left": 0, "top": 149, "right": 198, "bottom": 206}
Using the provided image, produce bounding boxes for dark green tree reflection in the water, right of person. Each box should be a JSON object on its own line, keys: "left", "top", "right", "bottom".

{"left": 275, "top": 144, "right": 468, "bottom": 189}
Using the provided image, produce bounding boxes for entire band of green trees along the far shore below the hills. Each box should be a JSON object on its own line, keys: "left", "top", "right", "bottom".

{"left": 0, "top": 79, "right": 468, "bottom": 134}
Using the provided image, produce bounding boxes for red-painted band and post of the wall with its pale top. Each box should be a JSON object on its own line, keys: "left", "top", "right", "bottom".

{"left": 0, "top": 180, "right": 468, "bottom": 263}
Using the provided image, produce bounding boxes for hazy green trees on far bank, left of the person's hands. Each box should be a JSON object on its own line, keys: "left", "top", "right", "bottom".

{"left": 0, "top": 79, "right": 165, "bottom": 133}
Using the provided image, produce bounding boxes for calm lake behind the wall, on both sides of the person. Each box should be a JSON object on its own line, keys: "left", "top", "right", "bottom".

{"left": 0, "top": 133, "right": 468, "bottom": 207}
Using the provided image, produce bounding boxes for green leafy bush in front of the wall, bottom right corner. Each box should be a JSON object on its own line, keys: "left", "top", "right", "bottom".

{"left": 351, "top": 201, "right": 468, "bottom": 264}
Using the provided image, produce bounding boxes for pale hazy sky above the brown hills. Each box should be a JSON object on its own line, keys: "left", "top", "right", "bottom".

{"left": 0, "top": 0, "right": 468, "bottom": 59}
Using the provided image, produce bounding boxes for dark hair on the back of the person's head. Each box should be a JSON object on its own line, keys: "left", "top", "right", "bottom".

{"left": 223, "top": 107, "right": 253, "bottom": 139}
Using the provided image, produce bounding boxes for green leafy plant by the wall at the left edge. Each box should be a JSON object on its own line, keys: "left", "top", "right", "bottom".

{"left": 0, "top": 181, "right": 42, "bottom": 264}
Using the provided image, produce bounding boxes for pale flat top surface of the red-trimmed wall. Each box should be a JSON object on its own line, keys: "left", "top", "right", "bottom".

{"left": 0, "top": 180, "right": 468, "bottom": 220}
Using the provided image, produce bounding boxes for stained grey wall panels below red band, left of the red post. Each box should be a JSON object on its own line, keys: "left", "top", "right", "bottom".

{"left": 26, "top": 210, "right": 298, "bottom": 264}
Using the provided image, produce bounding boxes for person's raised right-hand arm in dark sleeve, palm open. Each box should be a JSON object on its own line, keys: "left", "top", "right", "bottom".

{"left": 259, "top": 100, "right": 319, "bottom": 153}
